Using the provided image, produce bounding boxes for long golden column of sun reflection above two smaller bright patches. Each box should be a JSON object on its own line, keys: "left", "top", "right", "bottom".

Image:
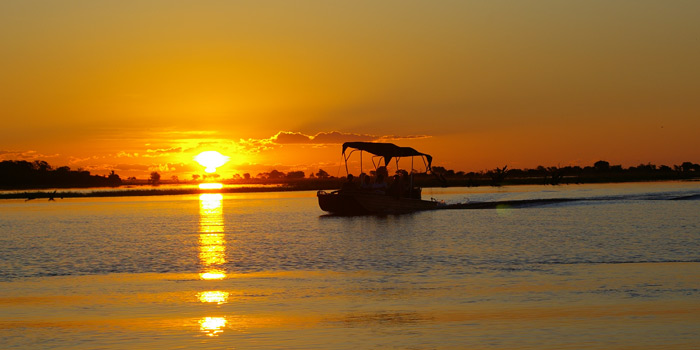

{"left": 199, "top": 193, "right": 226, "bottom": 280}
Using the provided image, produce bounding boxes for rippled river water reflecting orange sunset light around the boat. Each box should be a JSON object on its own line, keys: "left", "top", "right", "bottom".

{"left": 0, "top": 182, "right": 700, "bottom": 349}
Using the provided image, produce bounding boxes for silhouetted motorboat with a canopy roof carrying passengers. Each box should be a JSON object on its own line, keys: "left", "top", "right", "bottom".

{"left": 316, "top": 142, "right": 440, "bottom": 215}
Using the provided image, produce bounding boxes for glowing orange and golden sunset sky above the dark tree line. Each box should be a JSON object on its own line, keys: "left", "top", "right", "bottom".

{"left": 0, "top": 0, "right": 700, "bottom": 179}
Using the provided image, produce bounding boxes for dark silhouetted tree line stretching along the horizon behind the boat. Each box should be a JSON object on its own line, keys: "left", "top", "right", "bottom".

{"left": 0, "top": 160, "right": 700, "bottom": 188}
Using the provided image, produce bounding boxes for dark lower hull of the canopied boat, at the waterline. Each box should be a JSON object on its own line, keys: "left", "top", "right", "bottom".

{"left": 317, "top": 191, "right": 438, "bottom": 215}
